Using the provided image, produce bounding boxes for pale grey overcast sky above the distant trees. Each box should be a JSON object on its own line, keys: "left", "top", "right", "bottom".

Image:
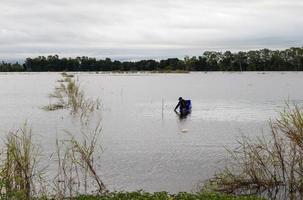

{"left": 0, "top": 0, "right": 303, "bottom": 60}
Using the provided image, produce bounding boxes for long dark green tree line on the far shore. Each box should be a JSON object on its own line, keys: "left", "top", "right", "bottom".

{"left": 0, "top": 47, "right": 303, "bottom": 72}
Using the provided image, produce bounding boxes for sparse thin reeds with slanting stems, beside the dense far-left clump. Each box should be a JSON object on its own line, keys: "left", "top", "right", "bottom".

{"left": 54, "top": 120, "right": 107, "bottom": 199}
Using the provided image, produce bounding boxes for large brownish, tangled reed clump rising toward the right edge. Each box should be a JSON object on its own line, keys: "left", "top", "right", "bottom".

{"left": 204, "top": 105, "right": 303, "bottom": 199}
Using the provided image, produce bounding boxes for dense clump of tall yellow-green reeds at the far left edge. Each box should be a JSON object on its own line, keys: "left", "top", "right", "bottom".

{"left": 0, "top": 124, "right": 44, "bottom": 199}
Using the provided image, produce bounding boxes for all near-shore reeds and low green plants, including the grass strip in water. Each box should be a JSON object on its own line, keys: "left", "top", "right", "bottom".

{"left": 0, "top": 73, "right": 303, "bottom": 200}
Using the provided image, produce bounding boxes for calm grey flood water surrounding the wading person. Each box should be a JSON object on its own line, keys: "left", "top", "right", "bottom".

{"left": 0, "top": 72, "right": 303, "bottom": 193}
